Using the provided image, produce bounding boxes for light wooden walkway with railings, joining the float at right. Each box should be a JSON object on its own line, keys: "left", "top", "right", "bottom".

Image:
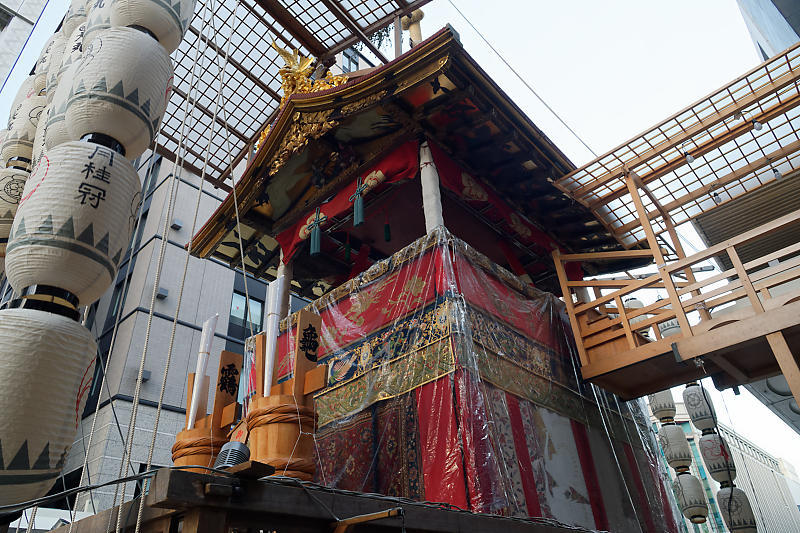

{"left": 553, "top": 202, "right": 800, "bottom": 399}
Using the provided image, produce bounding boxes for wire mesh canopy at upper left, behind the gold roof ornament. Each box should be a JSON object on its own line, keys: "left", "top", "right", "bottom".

{"left": 159, "top": 0, "right": 429, "bottom": 190}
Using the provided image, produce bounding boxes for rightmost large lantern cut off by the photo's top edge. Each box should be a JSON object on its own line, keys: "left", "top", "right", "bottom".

{"left": 111, "top": 0, "right": 194, "bottom": 53}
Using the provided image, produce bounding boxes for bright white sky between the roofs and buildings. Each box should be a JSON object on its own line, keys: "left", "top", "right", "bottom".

{"left": 0, "top": 0, "right": 800, "bottom": 470}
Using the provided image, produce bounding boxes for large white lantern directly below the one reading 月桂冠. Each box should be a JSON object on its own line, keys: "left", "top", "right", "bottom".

{"left": 0, "top": 309, "right": 97, "bottom": 505}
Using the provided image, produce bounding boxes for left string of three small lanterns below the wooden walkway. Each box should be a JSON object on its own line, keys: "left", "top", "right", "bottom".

{"left": 648, "top": 389, "right": 708, "bottom": 524}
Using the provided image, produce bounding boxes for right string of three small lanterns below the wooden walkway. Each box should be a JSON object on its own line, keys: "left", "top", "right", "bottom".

{"left": 683, "top": 381, "right": 757, "bottom": 533}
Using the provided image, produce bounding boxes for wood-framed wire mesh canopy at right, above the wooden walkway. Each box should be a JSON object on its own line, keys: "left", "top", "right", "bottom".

{"left": 556, "top": 45, "right": 800, "bottom": 245}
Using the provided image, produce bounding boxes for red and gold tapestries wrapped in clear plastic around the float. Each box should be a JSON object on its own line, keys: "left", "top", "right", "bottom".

{"left": 260, "top": 228, "right": 678, "bottom": 532}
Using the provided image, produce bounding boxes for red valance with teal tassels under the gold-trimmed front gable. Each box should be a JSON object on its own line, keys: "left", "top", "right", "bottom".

{"left": 277, "top": 141, "right": 419, "bottom": 262}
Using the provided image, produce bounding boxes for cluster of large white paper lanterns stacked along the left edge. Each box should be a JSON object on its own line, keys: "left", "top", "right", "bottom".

{"left": 0, "top": 0, "right": 194, "bottom": 510}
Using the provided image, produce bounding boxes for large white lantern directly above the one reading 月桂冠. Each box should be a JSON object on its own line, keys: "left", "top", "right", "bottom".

{"left": 66, "top": 28, "right": 172, "bottom": 160}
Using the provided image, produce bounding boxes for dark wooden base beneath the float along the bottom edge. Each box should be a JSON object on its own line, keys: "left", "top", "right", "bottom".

{"left": 54, "top": 469, "right": 589, "bottom": 533}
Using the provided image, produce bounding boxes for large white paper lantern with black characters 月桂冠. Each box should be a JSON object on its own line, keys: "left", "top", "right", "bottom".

{"left": 6, "top": 141, "right": 141, "bottom": 305}
